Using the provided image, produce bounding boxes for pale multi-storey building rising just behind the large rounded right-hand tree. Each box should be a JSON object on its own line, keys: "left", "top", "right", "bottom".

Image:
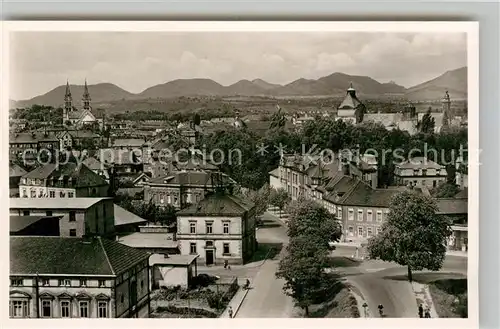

{"left": 394, "top": 157, "right": 447, "bottom": 188}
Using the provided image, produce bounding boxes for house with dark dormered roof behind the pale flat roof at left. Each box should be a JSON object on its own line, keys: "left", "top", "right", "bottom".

{"left": 19, "top": 162, "right": 109, "bottom": 198}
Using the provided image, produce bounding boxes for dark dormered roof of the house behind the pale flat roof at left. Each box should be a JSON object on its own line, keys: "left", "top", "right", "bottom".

{"left": 23, "top": 162, "right": 108, "bottom": 188}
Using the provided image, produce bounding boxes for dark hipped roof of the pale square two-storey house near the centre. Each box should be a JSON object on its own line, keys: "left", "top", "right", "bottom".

{"left": 177, "top": 194, "right": 253, "bottom": 217}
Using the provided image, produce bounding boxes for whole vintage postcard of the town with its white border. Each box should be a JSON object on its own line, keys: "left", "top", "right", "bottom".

{"left": 2, "top": 22, "right": 479, "bottom": 328}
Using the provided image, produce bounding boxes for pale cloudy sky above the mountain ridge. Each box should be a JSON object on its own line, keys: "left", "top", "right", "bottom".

{"left": 9, "top": 32, "right": 467, "bottom": 100}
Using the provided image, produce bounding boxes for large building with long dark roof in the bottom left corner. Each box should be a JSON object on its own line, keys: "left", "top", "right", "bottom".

{"left": 9, "top": 236, "right": 150, "bottom": 318}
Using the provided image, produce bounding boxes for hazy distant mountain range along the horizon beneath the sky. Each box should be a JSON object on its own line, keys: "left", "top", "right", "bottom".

{"left": 11, "top": 67, "right": 467, "bottom": 107}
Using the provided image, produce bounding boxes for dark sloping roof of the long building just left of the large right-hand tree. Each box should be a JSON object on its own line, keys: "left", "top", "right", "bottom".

{"left": 340, "top": 181, "right": 399, "bottom": 207}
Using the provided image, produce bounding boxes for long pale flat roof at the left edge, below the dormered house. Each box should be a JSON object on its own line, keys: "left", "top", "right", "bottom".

{"left": 9, "top": 198, "right": 110, "bottom": 209}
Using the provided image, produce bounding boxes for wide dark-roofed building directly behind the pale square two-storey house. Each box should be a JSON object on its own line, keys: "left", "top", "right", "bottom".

{"left": 144, "top": 171, "right": 234, "bottom": 209}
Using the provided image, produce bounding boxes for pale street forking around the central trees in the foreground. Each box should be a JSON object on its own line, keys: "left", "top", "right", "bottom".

{"left": 199, "top": 212, "right": 467, "bottom": 318}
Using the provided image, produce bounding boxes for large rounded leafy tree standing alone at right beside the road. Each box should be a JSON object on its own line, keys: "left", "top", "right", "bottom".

{"left": 368, "top": 191, "right": 452, "bottom": 282}
